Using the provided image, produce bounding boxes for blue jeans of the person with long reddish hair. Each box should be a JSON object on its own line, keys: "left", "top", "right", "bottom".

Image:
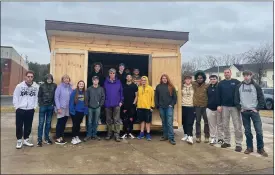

{"left": 159, "top": 107, "right": 174, "bottom": 140}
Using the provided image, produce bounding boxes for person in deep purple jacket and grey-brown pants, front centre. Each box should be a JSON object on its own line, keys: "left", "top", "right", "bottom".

{"left": 104, "top": 68, "right": 124, "bottom": 142}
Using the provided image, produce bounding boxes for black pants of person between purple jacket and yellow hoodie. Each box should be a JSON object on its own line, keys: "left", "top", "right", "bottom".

{"left": 122, "top": 107, "right": 136, "bottom": 134}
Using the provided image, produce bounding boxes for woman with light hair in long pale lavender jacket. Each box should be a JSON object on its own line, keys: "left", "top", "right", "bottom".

{"left": 54, "top": 75, "right": 72, "bottom": 145}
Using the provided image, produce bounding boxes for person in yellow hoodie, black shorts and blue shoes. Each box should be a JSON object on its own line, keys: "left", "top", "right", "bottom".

{"left": 137, "top": 76, "right": 155, "bottom": 141}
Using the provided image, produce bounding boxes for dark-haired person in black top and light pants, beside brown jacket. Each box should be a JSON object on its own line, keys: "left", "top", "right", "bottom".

{"left": 206, "top": 75, "right": 223, "bottom": 145}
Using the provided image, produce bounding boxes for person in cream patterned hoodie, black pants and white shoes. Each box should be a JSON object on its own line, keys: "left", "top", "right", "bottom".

{"left": 181, "top": 74, "right": 196, "bottom": 144}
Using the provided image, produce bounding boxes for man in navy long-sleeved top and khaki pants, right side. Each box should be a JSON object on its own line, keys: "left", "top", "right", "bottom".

{"left": 217, "top": 69, "right": 243, "bottom": 152}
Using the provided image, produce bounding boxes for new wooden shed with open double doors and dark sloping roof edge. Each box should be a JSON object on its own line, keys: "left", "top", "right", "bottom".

{"left": 45, "top": 20, "right": 189, "bottom": 131}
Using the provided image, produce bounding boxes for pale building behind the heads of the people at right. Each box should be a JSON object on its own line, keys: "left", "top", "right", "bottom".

{"left": 201, "top": 62, "right": 274, "bottom": 88}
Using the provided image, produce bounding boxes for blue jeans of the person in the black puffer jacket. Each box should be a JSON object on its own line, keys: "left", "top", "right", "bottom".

{"left": 38, "top": 105, "right": 54, "bottom": 141}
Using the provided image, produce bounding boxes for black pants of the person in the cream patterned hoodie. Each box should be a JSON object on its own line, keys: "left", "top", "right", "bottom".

{"left": 182, "top": 106, "right": 196, "bottom": 136}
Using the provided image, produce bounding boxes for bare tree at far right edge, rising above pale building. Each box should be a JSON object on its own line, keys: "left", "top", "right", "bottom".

{"left": 244, "top": 44, "right": 274, "bottom": 85}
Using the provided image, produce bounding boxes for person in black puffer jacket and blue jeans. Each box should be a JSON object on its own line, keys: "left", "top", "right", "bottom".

{"left": 37, "top": 74, "right": 57, "bottom": 147}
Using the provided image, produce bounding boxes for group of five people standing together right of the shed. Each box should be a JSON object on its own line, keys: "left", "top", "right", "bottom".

{"left": 182, "top": 69, "right": 268, "bottom": 156}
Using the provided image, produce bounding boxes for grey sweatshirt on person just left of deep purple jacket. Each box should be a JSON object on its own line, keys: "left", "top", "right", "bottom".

{"left": 86, "top": 86, "right": 105, "bottom": 109}
